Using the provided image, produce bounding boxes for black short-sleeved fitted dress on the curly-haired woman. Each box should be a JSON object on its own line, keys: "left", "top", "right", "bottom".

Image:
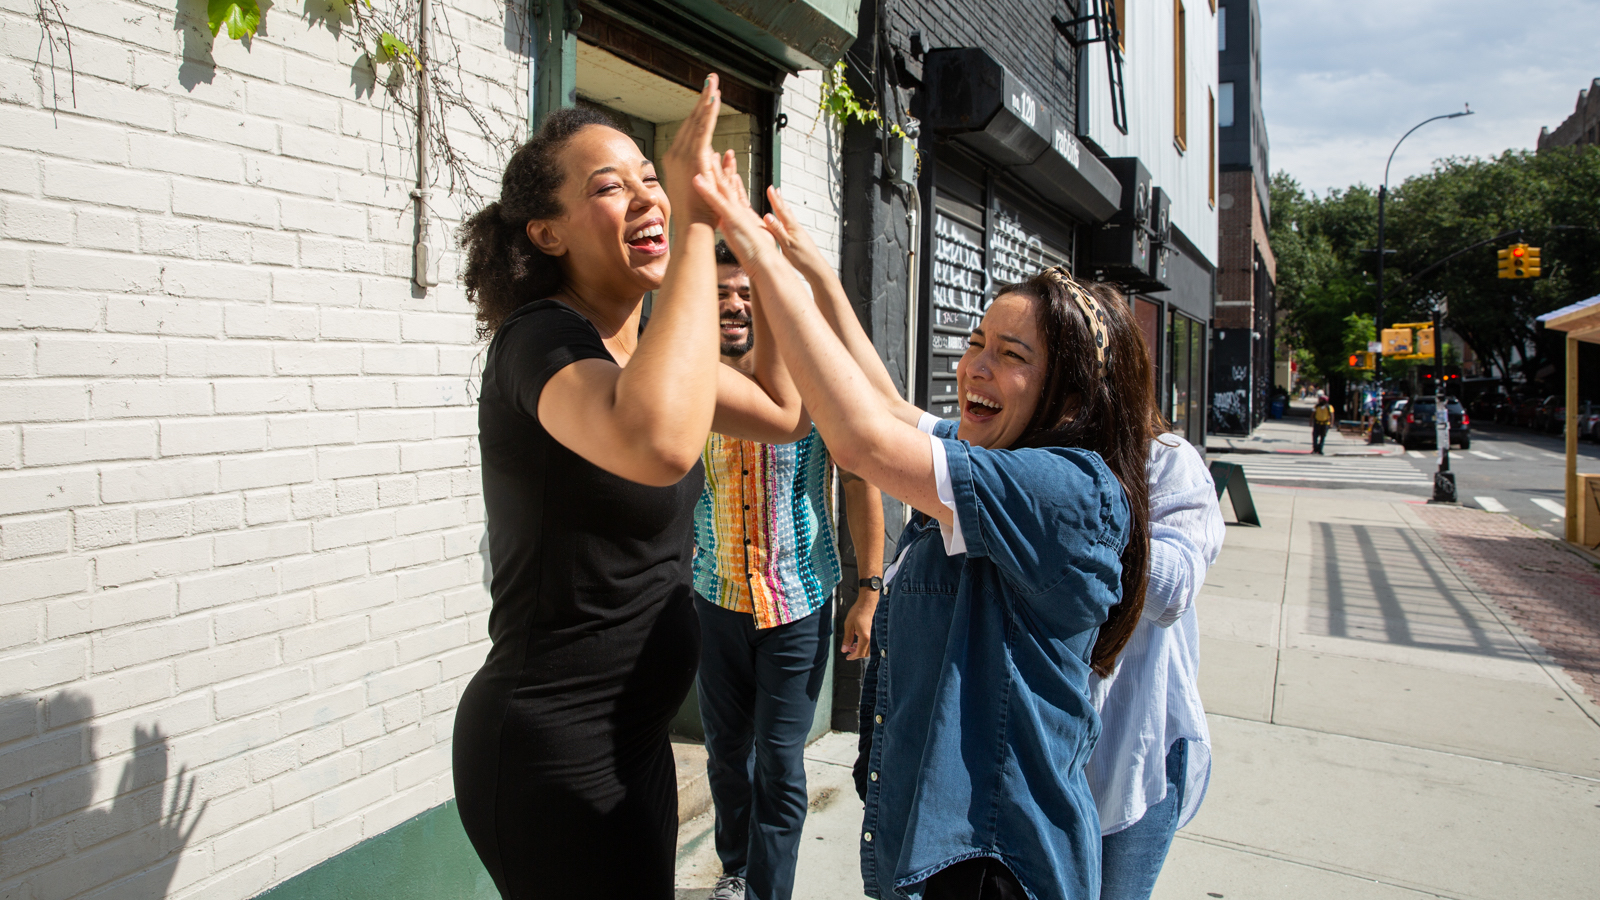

{"left": 454, "top": 299, "right": 702, "bottom": 900}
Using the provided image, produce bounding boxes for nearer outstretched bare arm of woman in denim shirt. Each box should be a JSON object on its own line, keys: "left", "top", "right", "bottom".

{"left": 694, "top": 160, "right": 954, "bottom": 525}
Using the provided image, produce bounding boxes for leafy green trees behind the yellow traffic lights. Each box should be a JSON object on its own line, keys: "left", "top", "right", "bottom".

{"left": 1272, "top": 147, "right": 1600, "bottom": 396}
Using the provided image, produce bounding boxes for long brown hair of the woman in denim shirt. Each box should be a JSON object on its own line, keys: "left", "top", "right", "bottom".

{"left": 1000, "top": 269, "right": 1160, "bottom": 677}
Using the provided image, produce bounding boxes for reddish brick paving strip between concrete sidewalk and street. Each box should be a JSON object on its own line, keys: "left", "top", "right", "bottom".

{"left": 1416, "top": 506, "right": 1600, "bottom": 703}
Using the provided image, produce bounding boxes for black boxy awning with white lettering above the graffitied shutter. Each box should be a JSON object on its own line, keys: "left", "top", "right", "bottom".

{"left": 920, "top": 46, "right": 1122, "bottom": 223}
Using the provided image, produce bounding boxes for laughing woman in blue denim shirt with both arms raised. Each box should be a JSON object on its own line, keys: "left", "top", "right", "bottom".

{"left": 696, "top": 160, "right": 1154, "bottom": 900}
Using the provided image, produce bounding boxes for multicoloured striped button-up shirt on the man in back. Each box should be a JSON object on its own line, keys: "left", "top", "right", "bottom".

{"left": 694, "top": 428, "right": 840, "bottom": 628}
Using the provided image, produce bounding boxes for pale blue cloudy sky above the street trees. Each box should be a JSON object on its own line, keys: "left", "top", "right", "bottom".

{"left": 1259, "top": 0, "right": 1600, "bottom": 194}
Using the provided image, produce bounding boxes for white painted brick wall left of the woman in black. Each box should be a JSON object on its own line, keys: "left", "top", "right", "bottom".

{"left": 0, "top": 0, "right": 524, "bottom": 900}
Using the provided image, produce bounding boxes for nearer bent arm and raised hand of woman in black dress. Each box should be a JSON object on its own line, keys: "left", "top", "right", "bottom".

{"left": 539, "top": 75, "right": 726, "bottom": 487}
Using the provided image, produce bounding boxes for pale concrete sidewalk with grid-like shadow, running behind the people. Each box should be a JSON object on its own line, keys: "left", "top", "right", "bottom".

{"left": 680, "top": 486, "right": 1600, "bottom": 900}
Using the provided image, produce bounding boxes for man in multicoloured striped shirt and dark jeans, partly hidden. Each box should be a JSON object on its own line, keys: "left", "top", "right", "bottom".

{"left": 694, "top": 243, "right": 883, "bottom": 900}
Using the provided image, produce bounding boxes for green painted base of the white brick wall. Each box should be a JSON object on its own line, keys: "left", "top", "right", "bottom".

{"left": 256, "top": 801, "right": 499, "bottom": 900}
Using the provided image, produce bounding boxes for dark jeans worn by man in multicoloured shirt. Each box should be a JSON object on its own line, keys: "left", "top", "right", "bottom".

{"left": 694, "top": 597, "right": 834, "bottom": 900}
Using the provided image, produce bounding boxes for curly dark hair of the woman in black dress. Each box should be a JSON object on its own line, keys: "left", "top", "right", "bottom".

{"left": 458, "top": 107, "right": 616, "bottom": 338}
